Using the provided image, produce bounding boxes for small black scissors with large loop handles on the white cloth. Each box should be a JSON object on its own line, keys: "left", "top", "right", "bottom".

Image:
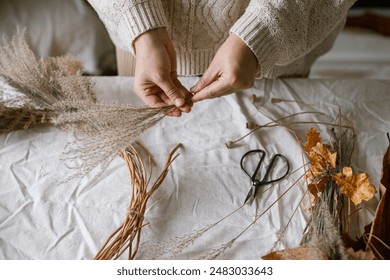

{"left": 240, "top": 150, "right": 290, "bottom": 205}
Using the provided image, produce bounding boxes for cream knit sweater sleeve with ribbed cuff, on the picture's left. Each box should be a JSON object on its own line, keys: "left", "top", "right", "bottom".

{"left": 88, "top": 0, "right": 167, "bottom": 53}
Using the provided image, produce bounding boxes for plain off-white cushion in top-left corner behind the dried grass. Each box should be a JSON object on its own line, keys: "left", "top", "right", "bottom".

{"left": 0, "top": 0, "right": 116, "bottom": 75}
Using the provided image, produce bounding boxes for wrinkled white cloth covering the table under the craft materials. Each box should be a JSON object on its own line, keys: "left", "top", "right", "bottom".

{"left": 0, "top": 77, "right": 390, "bottom": 259}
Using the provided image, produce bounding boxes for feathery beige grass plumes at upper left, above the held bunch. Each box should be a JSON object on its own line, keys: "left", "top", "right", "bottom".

{"left": 0, "top": 33, "right": 95, "bottom": 110}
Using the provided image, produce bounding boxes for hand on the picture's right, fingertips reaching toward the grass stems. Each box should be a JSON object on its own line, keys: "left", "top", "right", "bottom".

{"left": 191, "top": 34, "right": 257, "bottom": 102}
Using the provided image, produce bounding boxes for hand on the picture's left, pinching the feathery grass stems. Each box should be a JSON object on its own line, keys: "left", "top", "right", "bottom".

{"left": 134, "top": 28, "right": 192, "bottom": 116}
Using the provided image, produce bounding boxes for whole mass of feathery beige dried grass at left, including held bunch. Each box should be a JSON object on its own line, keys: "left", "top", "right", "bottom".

{"left": 0, "top": 34, "right": 167, "bottom": 177}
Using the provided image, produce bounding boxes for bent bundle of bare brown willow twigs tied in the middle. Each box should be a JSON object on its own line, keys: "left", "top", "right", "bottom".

{"left": 95, "top": 145, "right": 180, "bottom": 260}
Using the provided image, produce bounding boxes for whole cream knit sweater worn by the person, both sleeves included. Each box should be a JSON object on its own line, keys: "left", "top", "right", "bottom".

{"left": 88, "top": 0, "right": 356, "bottom": 78}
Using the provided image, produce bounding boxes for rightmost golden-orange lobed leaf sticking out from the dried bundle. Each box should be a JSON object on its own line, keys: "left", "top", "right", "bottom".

{"left": 333, "top": 166, "right": 375, "bottom": 205}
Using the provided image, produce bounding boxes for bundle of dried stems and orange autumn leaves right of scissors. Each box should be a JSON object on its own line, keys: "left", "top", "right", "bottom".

{"left": 302, "top": 128, "right": 376, "bottom": 259}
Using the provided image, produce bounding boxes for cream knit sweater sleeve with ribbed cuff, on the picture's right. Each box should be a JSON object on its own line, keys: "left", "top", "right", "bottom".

{"left": 230, "top": 0, "right": 356, "bottom": 77}
